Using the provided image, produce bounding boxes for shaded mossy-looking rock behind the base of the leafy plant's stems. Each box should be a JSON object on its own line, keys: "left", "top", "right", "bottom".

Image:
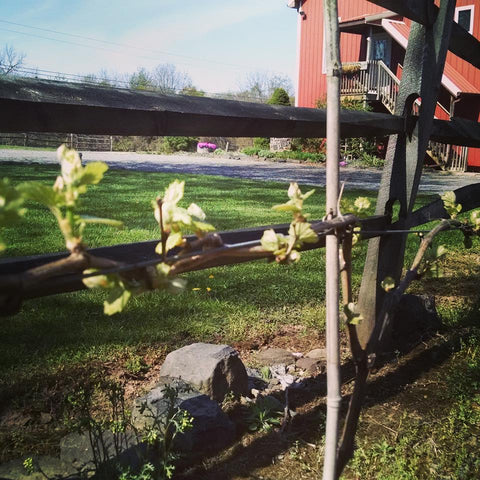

{"left": 60, "top": 430, "right": 141, "bottom": 471}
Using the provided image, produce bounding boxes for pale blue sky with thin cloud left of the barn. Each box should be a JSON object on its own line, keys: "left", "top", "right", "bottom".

{"left": 0, "top": 0, "right": 297, "bottom": 92}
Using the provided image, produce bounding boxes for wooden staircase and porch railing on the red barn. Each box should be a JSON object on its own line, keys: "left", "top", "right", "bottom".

{"left": 340, "top": 60, "right": 468, "bottom": 172}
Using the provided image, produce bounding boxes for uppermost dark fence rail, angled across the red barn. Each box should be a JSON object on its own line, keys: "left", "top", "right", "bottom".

{"left": 369, "top": 0, "right": 480, "bottom": 68}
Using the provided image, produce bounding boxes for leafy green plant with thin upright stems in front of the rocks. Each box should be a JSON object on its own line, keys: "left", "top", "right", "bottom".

{"left": 64, "top": 380, "right": 193, "bottom": 480}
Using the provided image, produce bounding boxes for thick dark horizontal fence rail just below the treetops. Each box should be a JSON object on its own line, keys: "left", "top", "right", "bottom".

{"left": 0, "top": 77, "right": 404, "bottom": 137}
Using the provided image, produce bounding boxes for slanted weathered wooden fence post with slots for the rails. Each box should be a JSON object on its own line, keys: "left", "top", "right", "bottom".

{"left": 356, "top": 0, "right": 455, "bottom": 350}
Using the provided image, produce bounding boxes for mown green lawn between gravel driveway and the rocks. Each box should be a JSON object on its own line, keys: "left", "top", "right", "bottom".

{"left": 0, "top": 165, "right": 376, "bottom": 379}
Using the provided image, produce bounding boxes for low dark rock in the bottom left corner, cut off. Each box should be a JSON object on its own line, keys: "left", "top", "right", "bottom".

{"left": 0, "top": 456, "right": 81, "bottom": 480}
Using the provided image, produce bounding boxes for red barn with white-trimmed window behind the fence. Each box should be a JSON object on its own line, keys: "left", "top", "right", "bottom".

{"left": 289, "top": 0, "right": 480, "bottom": 170}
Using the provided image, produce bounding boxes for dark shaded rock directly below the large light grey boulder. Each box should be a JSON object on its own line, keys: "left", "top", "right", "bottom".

{"left": 132, "top": 378, "right": 235, "bottom": 453}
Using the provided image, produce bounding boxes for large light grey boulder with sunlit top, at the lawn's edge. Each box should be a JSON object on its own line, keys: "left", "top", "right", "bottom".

{"left": 160, "top": 343, "right": 248, "bottom": 402}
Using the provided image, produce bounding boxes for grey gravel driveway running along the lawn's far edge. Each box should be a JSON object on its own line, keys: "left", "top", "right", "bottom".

{"left": 0, "top": 149, "right": 480, "bottom": 193}
